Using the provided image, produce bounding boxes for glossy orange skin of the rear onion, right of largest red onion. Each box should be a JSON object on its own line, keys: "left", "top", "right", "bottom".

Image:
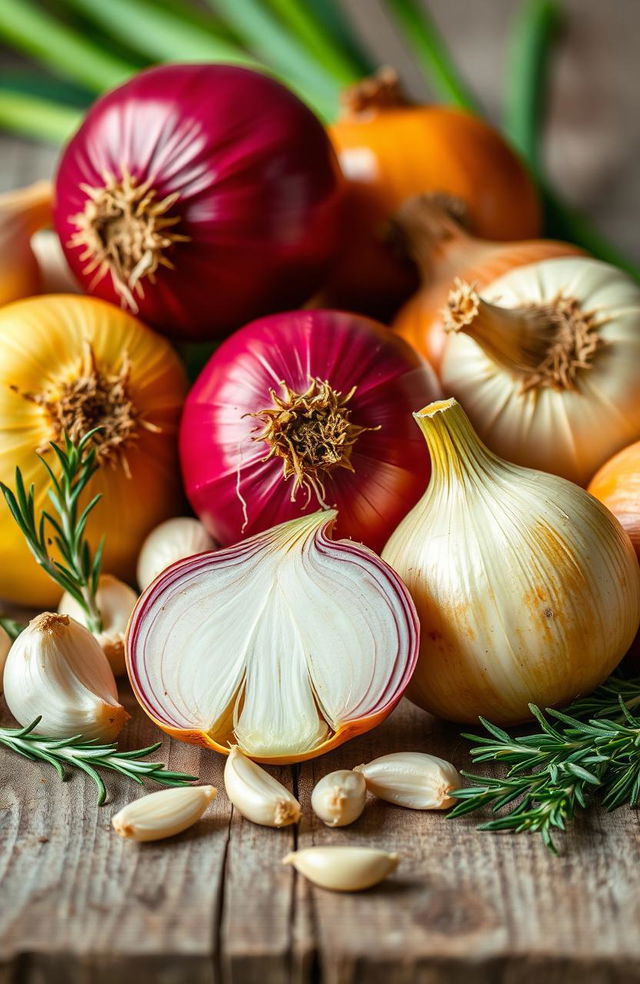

{"left": 326, "top": 73, "right": 540, "bottom": 319}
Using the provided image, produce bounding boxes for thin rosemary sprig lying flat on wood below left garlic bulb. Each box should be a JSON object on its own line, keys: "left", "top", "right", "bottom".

{"left": 0, "top": 718, "right": 198, "bottom": 806}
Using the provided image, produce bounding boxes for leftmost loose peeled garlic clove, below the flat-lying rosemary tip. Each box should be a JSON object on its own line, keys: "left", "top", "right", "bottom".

{"left": 111, "top": 786, "right": 218, "bottom": 841}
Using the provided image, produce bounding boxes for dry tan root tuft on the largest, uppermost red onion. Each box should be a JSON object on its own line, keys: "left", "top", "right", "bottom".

{"left": 70, "top": 168, "right": 189, "bottom": 311}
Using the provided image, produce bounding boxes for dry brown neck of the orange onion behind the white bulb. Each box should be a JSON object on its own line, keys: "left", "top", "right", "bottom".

{"left": 391, "top": 192, "right": 476, "bottom": 283}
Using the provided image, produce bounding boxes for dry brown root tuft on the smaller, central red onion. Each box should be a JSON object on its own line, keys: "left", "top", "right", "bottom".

{"left": 249, "top": 379, "right": 377, "bottom": 508}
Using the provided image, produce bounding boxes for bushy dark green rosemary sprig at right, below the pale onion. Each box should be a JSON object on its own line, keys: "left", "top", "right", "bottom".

{"left": 450, "top": 675, "right": 640, "bottom": 851}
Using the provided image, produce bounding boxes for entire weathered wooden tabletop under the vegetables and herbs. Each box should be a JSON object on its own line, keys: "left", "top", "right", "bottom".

{"left": 0, "top": 684, "right": 640, "bottom": 984}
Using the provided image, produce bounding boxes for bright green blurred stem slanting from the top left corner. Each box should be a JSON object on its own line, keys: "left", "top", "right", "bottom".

{"left": 0, "top": 0, "right": 135, "bottom": 92}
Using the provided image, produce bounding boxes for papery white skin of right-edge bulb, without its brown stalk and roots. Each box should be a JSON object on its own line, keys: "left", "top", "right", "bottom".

{"left": 440, "top": 256, "right": 640, "bottom": 486}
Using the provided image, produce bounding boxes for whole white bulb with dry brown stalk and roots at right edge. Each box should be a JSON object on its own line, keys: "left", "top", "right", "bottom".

{"left": 441, "top": 257, "right": 640, "bottom": 485}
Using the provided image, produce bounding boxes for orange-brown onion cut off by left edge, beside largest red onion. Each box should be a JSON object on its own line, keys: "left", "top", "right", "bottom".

{"left": 0, "top": 181, "right": 51, "bottom": 306}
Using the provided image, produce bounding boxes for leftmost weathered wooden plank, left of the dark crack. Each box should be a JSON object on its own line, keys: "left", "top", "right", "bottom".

{"left": 0, "top": 694, "right": 231, "bottom": 984}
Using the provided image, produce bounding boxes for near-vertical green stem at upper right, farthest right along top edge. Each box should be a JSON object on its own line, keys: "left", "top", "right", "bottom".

{"left": 504, "top": 0, "right": 560, "bottom": 169}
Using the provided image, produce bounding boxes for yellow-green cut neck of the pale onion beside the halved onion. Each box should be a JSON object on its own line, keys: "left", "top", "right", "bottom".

{"left": 413, "top": 399, "right": 499, "bottom": 482}
